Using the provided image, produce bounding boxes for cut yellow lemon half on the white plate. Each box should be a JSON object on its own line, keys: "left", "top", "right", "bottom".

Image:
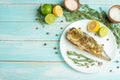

{"left": 87, "top": 20, "right": 100, "bottom": 32}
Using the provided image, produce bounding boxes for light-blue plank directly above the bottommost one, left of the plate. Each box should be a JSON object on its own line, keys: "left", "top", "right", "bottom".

{"left": 0, "top": 41, "right": 63, "bottom": 61}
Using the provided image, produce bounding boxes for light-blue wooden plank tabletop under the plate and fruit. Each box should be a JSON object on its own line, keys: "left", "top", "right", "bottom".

{"left": 0, "top": 0, "right": 120, "bottom": 80}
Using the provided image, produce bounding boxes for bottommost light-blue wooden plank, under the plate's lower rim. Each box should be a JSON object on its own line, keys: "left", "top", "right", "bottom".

{"left": 0, "top": 62, "right": 120, "bottom": 80}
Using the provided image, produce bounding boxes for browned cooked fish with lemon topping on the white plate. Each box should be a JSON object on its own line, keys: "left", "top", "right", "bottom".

{"left": 66, "top": 28, "right": 111, "bottom": 61}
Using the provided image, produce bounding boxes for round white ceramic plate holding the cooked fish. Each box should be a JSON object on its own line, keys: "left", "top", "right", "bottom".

{"left": 60, "top": 20, "right": 117, "bottom": 73}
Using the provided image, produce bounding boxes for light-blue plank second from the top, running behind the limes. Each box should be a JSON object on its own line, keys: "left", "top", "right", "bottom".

{"left": 0, "top": 4, "right": 112, "bottom": 22}
